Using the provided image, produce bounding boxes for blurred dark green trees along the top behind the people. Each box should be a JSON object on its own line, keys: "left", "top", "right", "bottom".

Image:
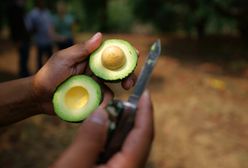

{"left": 0, "top": 0, "right": 248, "bottom": 37}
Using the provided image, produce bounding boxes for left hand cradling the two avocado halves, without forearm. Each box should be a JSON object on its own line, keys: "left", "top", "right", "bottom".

{"left": 32, "top": 33, "right": 135, "bottom": 114}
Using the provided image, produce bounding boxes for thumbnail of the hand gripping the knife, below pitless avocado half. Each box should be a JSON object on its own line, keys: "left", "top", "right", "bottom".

{"left": 89, "top": 108, "right": 108, "bottom": 125}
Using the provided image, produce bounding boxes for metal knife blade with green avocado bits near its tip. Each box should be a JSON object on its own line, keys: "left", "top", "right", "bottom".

{"left": 128, "top": 39, "right": 161, "bottom": 106}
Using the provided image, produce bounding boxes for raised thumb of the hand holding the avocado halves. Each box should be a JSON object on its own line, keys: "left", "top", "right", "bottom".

{"left": 59, "top": 32, "right": 102, "bottom": 63}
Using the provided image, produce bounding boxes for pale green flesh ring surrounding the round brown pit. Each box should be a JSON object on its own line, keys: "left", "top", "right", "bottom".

{"left": 89, "top": 39, "right": 138, "bottom": 81}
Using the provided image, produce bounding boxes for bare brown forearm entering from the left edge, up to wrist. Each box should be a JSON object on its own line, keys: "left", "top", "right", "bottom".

{"left": 0, "top": 77, "right": 42, "bottom": 126}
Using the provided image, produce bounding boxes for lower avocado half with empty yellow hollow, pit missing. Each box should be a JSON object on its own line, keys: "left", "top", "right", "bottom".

{"left": 53, "top": 75, "right": 102, "bottom": 122}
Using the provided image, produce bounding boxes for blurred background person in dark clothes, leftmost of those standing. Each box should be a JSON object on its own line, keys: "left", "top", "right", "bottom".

{"left": 7, "top": 0, "right": 30, "bottom": 77}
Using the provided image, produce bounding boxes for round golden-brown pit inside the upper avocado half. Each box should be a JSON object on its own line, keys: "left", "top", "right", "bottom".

{"left": 102, "top": 46, "right": 126, "bottom": 70}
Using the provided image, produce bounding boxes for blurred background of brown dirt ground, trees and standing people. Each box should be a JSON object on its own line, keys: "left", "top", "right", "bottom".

{"left": 0, "top": 0, "right": 248, "bottom": 168}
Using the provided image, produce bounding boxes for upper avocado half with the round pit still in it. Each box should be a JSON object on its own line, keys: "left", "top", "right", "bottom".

{"left": 89, "top": 39, "right": 138, "bottom": 81}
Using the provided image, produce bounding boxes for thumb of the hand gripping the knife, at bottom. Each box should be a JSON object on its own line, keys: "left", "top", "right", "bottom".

{"left": 51, "top": 108, "right": 108, "bottom": 168}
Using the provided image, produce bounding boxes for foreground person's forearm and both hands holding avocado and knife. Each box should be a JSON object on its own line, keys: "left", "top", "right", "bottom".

{"left": 0, "top": 33, "right": 154, "bottom": 168}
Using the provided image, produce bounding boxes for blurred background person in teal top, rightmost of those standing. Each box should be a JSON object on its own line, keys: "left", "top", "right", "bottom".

{"left": 53, "top": 1, "right": 75, "bottom": 50}
